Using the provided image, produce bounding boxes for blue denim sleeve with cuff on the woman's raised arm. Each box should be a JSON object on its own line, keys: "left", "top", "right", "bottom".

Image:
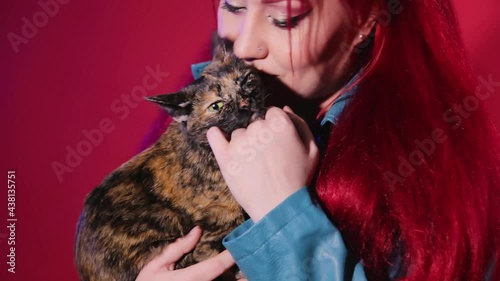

{"left": 223, "top": 187, "right": 366, "bottom": 281}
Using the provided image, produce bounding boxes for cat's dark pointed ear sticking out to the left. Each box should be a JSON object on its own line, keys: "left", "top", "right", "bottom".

{"left": 145, "top": 89, "right": 194, "bottom": 123}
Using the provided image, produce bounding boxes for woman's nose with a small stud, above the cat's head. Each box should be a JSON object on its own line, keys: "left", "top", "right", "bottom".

{"left": 233, "top": 12, "right": 269, "bottom": 61}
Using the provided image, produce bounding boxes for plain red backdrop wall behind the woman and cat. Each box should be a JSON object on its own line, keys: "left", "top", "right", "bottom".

{"left": 0, "top": 0, "right": 500, "bottom": 280}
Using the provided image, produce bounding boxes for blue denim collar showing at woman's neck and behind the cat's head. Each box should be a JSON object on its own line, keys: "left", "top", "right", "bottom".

{"left": 191, "top": 61, "right": 359, "bottom": 127}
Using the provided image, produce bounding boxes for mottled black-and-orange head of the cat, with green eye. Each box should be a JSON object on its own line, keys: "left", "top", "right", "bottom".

{"left": 146, "top": 50, "right": 265, "bottom": 145}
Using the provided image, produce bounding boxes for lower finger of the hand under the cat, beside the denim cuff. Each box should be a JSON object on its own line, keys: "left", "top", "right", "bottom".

{"left": 176, "top": 250, "right": 234, "bottom": 280}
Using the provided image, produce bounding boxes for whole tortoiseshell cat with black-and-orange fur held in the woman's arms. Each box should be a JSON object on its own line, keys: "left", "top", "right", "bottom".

{"left": 75, "top": 47, "right": 265, "bottom": 281}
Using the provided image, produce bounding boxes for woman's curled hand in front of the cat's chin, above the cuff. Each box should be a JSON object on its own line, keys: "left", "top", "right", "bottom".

{"left": 207, "top": 107, "right": 319, "bottom": 222}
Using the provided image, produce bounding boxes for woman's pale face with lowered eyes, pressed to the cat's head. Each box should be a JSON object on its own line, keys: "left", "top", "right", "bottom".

{"left": 218, "top": 0, "right": 356, "bottom": 108}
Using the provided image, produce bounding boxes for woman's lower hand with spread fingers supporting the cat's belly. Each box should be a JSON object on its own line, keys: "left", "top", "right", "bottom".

{"left": 135, "top": 227, "right": 234, "bottom": 281}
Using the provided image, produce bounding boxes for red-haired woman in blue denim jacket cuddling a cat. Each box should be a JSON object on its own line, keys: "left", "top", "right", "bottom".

{"left": 137, "top": 0, "right": 500, "bottom": 280}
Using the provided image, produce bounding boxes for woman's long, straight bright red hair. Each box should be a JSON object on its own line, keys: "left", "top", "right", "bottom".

{"left": 316, "top": 0, "right": 500, "bottom": 281}
